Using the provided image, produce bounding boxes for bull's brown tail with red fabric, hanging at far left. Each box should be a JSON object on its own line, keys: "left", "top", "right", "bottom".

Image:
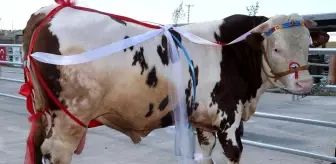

{"left": 23, "top": 8, "right": 48, "bottom": 164}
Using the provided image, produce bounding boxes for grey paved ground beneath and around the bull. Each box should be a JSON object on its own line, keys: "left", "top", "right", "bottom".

{"left": 0, "top": 68, "right": 336, "bottom": 164}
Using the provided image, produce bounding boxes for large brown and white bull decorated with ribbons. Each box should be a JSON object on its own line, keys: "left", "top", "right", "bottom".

{"left": 23, "top": 1, "right": 323, "bottom": 164}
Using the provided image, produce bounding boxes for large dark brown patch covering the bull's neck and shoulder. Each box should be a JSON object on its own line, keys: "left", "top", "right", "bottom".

{"left": 209, "top": 15, "right": 266, "bottom": 129}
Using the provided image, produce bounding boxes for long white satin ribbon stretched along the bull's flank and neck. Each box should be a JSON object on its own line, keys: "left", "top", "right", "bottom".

{"left": 32, "top": 26, "right": 250, "bottom": 65}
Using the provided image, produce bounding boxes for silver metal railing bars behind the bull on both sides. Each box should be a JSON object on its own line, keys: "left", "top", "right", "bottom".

{"left": 0, "top": 44, "right": 336, "bottom": 163}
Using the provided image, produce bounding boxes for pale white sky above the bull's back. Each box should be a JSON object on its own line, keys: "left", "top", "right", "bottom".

{"left": 0, "top": 0, "right": 336, "bottom": 29}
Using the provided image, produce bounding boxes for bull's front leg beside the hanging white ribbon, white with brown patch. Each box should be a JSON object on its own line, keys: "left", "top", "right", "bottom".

{"left": 196, "top": 128, "right": 216, "bottom": 164}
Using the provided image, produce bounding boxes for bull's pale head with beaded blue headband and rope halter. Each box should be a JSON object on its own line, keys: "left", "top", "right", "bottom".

{"left": 247, "top": 14, "right": 329, "bottom": 94}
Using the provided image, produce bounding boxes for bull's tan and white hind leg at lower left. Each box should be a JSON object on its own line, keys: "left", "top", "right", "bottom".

{"left": 41, "top": 110, "right": 86, "bottom": 164}
